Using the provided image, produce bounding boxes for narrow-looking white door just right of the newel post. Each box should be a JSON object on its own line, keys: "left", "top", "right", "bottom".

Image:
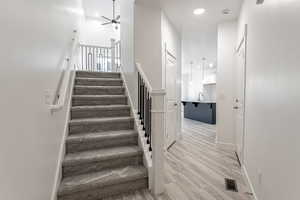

{"left": 165, "top": 50, "right": 178, "bottom": 148}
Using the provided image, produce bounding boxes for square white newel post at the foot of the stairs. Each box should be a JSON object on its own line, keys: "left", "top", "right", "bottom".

{"left": 151, "top": 90, "right": 166, "bottom": 195}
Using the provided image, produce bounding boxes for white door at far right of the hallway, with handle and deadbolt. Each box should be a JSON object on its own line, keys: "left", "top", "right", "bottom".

{"left": 233, "top": 27, "right": 247, "bottom": 164}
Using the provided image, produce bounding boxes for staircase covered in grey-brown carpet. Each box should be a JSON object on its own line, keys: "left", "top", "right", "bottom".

{"left": 57, "top": 71, "right": 148, "bottom": 200}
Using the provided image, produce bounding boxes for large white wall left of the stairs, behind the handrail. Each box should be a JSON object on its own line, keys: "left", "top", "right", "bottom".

{"left": 0, "top": 0, "right": 81, "bottom": 200}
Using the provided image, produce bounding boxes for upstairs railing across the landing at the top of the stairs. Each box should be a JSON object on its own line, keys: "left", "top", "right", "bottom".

{"left": 77, "top": 39, "right": 121, "bottom": 72}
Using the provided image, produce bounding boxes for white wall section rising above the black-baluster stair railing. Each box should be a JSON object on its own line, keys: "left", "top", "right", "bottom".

{"left": 134, "top": 1, "right": 163, "bottom": 89}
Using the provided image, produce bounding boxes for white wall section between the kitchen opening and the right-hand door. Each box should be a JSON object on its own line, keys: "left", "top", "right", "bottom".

{"left": 216, "top": 21, "right": 237, "bottom": 147}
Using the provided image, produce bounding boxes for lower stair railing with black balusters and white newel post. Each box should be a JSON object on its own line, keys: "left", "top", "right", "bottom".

{"left": 136, "top": 63, "right": 165, "bottom": 195}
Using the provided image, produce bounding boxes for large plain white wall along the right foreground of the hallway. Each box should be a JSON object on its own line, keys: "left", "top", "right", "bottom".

{"left": 239, "top": 0, "right": 300, "bottom": 200}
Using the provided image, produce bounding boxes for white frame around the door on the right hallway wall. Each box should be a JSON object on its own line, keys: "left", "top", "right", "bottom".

{"left": 234, "top": 24, "right": 248, "bottom": 165}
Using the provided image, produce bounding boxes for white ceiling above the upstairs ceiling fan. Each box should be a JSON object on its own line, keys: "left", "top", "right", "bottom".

{"left": 82, "top": 0, "right": 122, "bottom": 22}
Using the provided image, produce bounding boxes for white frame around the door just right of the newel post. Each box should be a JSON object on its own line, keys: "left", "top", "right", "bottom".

{"left": 163, "top": 43, "right": 180, "bottom": 150}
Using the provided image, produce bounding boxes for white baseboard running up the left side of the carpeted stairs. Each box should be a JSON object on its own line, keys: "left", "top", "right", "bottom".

{"left": 51, "top": 71, "right": 75, "bottom": 200}
